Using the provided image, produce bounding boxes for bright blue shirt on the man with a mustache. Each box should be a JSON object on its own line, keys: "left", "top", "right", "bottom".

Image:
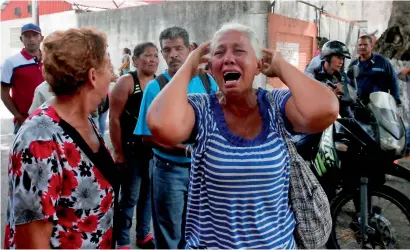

{"left": 134, "top": 72, "right": 218, "bottom": 163}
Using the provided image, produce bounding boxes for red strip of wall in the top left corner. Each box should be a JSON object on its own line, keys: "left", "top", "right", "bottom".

{"left": 0, "top": 0, "right": 72, "bottom": 21}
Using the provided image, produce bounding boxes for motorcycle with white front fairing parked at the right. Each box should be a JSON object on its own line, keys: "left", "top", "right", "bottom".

{"left": 296, "top": 65, "right": 410, "bottom": 249}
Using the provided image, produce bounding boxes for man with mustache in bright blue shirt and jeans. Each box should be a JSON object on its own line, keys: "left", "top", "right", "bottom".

{"left": 134, "top": 27, "right": 217, "bottom": 249}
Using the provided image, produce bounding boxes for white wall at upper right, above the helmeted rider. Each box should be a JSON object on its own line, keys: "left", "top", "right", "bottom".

{"left": 275, "top": 0, "right": 392, "bottom": 71}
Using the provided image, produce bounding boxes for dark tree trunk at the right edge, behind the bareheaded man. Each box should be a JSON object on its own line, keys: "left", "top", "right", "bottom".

{"left": 374, "top": 1, "right": 410, "bottom": 126}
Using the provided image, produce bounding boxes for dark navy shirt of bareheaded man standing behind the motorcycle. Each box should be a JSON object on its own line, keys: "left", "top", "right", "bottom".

{"left": 349, "top": 53, "right": 401, "bottom": 104}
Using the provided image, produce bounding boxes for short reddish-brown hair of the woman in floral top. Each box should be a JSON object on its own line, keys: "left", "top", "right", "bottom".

{"left": 43, "top": 28, "right": 107, "bottom": 96}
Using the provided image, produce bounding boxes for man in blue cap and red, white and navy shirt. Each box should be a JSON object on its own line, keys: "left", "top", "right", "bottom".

{"left": 1, "top": 23, "right": 44, "bottom": 134}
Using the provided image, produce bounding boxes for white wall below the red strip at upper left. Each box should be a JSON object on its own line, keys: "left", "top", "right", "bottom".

{"left": 0, "top": 11, "right": 77, "bottom": 66}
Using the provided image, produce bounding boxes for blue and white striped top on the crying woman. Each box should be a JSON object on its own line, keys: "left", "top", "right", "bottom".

{"left": 185, "top": 89, "right": 296, "bottom": 249}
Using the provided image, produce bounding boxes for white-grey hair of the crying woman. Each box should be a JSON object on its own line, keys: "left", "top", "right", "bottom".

{"left": 211, "top": 22, "right": 262, "bottom": 59}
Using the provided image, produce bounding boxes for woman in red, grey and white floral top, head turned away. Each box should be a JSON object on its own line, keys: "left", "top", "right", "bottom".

{"left": 4, "top": 29, "right": 118, "bottom": 249}
